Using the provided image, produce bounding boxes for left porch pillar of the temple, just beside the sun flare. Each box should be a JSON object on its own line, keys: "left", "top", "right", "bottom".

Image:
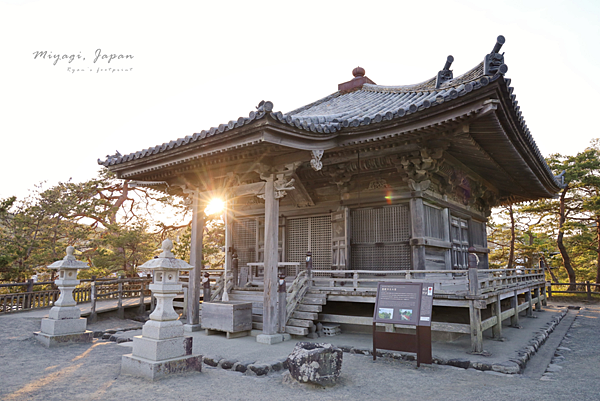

{"left": 187, "top": 192, "right": 206, "bottom": 331}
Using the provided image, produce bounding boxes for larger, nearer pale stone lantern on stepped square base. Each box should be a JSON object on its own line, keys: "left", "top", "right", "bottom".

{"left": 121, "top": 239, "right": 202, "bottom": 380}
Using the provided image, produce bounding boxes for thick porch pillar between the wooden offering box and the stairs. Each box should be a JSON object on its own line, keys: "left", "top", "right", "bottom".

{"left": 263, "top": 175, "right": 279, "bottom": 335}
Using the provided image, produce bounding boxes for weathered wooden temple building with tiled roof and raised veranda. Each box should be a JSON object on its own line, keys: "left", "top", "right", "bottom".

{"left": 99, "top": 36, "right": 561, "bottom": 352}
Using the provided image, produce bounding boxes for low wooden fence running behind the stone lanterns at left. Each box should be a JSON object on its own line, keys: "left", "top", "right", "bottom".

{"left": 0, "top": 277, "right": 152, "bottom": 314}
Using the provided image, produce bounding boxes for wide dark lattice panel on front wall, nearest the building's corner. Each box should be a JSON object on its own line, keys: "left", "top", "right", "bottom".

{"left": 351, "top": 205, "right": 410, "bottom": 271}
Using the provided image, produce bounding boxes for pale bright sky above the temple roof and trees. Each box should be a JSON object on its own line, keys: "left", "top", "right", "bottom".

{"left": 0, "top": 0, "right": 600, "bottom": 199}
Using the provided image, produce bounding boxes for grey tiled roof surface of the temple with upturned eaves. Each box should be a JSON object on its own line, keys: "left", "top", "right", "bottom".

{"left": 98, "top": 48, "right": 560, "bottom": 189}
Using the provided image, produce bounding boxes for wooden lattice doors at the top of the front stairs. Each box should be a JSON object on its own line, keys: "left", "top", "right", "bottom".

{"left": 286, "top": 216, "right": 331, "bottom": 275}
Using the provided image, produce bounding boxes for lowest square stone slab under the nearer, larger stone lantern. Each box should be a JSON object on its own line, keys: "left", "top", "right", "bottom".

{"left": 121, "top": 354, "right": 202, "bottom": 380}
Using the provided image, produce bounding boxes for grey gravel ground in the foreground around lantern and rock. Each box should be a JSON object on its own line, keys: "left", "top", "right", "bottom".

{"left": 0, "top": 305, "right": 600, "bottom": 400}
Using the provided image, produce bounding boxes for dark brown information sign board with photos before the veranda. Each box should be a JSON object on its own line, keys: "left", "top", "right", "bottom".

{"left": 373, "top": 282, "right": 433, "bottom": 367}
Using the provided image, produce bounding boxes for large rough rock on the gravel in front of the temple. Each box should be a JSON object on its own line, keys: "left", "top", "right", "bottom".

{"left": 286, "top": 342, "right": 343, "bottom": 386}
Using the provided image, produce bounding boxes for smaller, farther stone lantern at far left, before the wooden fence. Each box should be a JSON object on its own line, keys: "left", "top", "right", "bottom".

{"left": 34, "top": 246, "right": 93, "bottom": 347}
